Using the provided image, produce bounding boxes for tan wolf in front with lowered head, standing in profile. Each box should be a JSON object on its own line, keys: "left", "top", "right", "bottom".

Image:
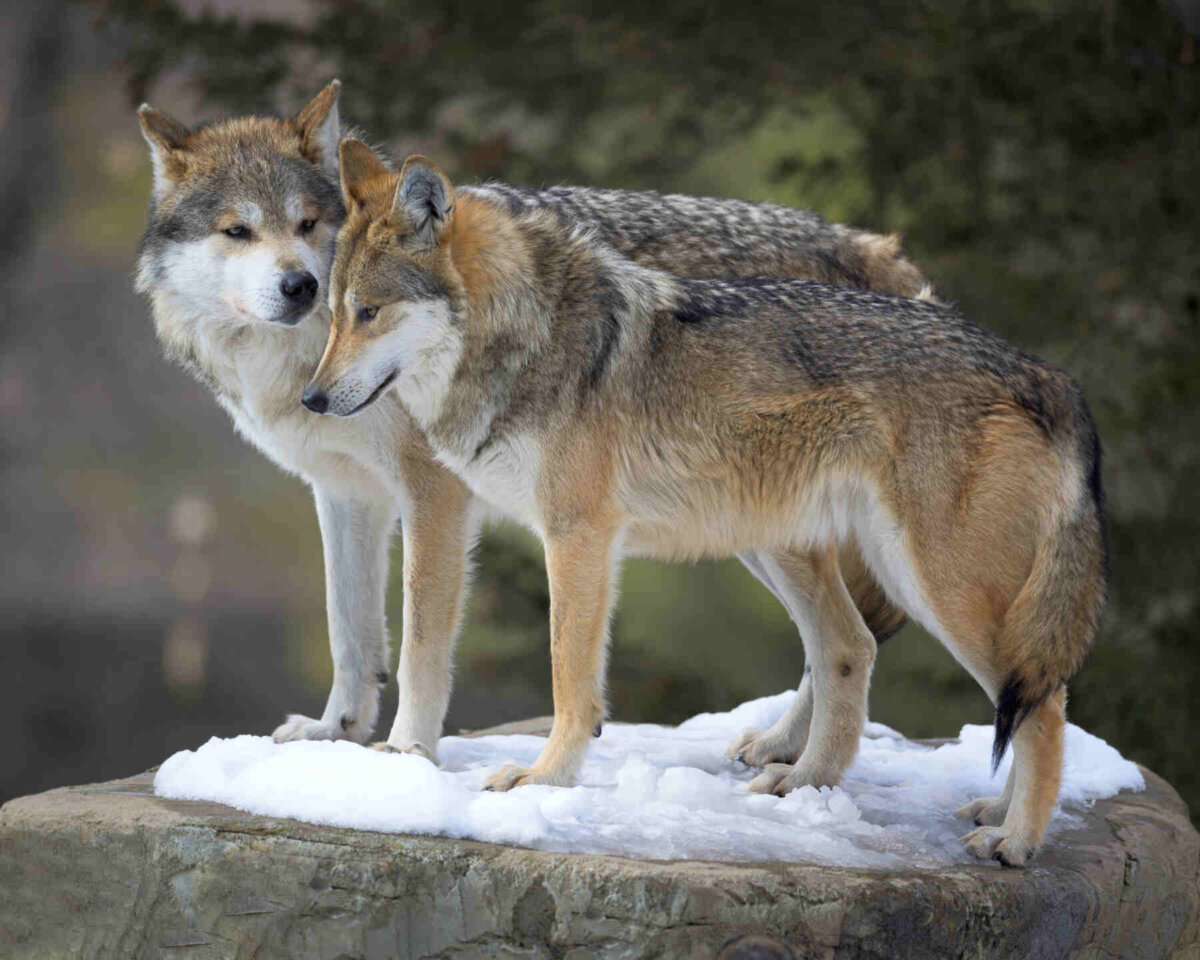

{"left": 302, "top": 139, "right": 1106, "bottom": 865}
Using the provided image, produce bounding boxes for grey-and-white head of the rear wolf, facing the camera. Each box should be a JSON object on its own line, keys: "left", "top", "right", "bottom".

{"left": 137, "top": 80, "right": 344, "bottom": 325}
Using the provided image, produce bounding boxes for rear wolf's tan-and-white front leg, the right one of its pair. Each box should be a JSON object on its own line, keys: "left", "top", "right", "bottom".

{"left": 376, "top": 462, "right": 478, "bottom": 762}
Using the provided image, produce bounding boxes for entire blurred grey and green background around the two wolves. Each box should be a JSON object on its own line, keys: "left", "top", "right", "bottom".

{"left": 0, "top": 0, "right": 1200, "bottom": 825}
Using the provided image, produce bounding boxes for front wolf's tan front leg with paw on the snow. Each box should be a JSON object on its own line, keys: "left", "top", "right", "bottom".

{"left": 486, "top": 523, "right": 616, "bottom": 791}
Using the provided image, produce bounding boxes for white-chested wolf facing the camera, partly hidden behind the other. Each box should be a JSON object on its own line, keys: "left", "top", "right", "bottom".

{"left": 136, "top": 80, "right": 926, "bottom": 763}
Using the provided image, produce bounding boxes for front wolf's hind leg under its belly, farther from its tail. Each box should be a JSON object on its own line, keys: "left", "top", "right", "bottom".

{"left": 750, "top": 547, "right": 876, "bottom": 794}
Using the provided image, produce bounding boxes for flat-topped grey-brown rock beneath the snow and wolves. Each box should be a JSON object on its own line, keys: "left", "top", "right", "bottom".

{"left": 0, "top": 729, "right": 1200, "bottom": 960}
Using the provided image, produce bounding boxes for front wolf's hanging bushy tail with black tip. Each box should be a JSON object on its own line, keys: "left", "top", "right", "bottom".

{"left": 991, "top": 372, "right": 1109, "bottom": 773}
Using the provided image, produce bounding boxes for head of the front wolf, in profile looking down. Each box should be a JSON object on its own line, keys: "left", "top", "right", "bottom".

{"left": 302, "top": 139, "right": 466, "bottom": 418}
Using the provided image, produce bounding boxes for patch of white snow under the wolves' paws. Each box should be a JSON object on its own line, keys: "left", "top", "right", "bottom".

{"left": 155, "top": 692, "right": 1145, "bottom": 869}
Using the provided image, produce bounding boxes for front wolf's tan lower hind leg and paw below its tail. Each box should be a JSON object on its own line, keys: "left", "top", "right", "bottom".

{"left": 962, "top": 688, "right": 1067, "bottom": 866}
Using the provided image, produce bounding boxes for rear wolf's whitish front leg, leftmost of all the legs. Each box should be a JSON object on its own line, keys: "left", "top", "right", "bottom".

{"left": 272, "top": 486, "right": 397, "bottom": 743}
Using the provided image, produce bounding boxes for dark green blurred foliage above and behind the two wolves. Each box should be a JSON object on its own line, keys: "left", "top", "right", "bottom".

{"left": 91, "top": 0, "right": 1200, "bottom": 806}
